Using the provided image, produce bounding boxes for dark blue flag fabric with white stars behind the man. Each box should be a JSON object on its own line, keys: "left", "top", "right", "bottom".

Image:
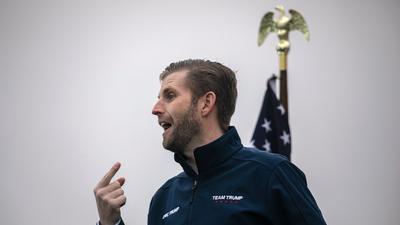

{"left": 251, "top": 75, "right": 292, "bottom": 160}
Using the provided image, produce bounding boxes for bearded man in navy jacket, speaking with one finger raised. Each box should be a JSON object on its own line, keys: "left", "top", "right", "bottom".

{"left": 95, "top": 60, "right": 325, "bottom": 225}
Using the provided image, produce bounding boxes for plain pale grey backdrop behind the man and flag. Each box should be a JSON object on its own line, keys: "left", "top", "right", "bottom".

{"left": 0, "top": 0, "right": 400, "bottom": 225}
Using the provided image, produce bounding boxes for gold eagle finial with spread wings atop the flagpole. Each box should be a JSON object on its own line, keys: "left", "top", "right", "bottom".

{"left": 258, "top": 5, "right": 310, "bottom": 54}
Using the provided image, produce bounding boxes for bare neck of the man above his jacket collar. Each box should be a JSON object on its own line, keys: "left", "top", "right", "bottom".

{"left": 183, "top": 126, "right": 224, "bottom": 174}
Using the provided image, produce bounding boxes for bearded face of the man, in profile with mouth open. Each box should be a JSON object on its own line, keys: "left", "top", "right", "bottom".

{"left": 152, "top": 71, "right": 200, "bottom": 152}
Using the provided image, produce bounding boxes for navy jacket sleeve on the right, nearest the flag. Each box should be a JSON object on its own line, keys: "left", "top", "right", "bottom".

{"left": 267, "top": 161, "right": 326, "bottom": 225}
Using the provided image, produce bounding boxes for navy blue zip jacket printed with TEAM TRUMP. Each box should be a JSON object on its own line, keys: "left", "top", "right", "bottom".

{"left": 148, "top": 127, "right": 326, "bottom": 225}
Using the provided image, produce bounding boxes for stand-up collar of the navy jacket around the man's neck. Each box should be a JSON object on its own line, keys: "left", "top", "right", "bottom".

{"left": 175, "top": 127, "right": 243, "bottom": 176}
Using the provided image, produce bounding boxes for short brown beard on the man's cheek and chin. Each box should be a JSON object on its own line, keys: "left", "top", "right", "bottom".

{"left": 163, "top": 105, "right": 200, "bottom": 153}
